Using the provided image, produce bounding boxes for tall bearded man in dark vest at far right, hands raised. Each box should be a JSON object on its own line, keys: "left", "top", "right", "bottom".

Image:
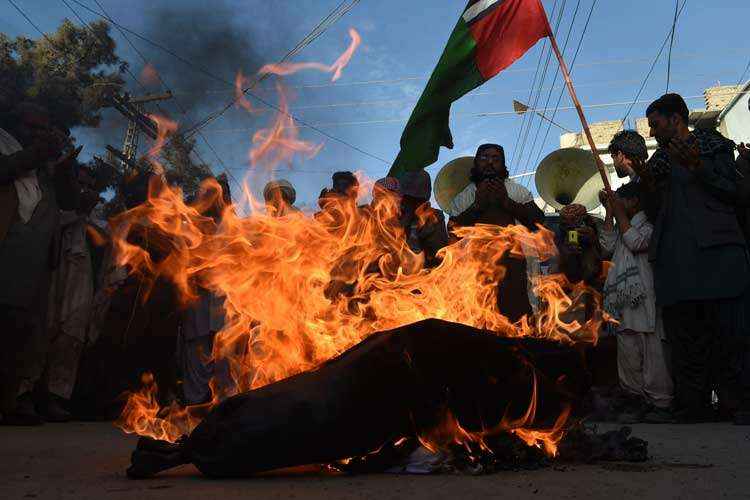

{"left": 646, "top": 94, "right": 750, "bottom": 423}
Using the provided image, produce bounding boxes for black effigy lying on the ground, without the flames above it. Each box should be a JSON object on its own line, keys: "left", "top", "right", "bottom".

{"left": 129, "top": 320, "right": 588, "bottom": 477}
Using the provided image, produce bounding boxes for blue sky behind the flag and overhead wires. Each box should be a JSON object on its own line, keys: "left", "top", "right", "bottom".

{"left": 0, "top": 0, "right": 750, "bottom": 203}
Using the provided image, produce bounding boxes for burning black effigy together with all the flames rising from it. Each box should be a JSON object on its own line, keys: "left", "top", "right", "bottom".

{"left": 110, "top": 25, "right": 644, "bottom": 477}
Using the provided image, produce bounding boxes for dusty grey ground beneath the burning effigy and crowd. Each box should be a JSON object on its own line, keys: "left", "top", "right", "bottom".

{"left": 0, "top": 423, "right": 750, "bottom": 500}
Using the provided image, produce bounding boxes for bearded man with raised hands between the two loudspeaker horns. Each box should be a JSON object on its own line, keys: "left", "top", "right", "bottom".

{"left": 447, "top": 144, "right": 544, "bottom": 322}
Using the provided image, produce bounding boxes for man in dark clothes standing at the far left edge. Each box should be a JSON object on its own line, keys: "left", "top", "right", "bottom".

{"left": 0, "top": 103, "right": 80, "bottom": 425}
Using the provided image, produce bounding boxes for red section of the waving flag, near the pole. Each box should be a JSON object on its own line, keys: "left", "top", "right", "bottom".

{"left": 469, "top": 0, "right": 551, "bottom": 80}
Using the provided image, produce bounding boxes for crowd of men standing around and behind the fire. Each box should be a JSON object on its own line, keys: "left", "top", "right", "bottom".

{"left": 0, "top": 94, "right": 750, "bottom": 425}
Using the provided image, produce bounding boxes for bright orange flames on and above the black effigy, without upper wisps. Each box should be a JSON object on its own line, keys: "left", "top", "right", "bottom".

{"left": 112, "top": 181, "right": 600, "bottom": 450}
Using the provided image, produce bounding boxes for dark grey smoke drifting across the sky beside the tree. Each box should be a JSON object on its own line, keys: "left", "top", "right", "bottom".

{"left": 77, "top": 0, "right": 290, "bottom": 162}
